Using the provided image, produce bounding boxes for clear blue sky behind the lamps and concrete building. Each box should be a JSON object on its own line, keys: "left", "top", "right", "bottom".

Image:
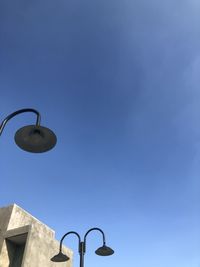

{"left": 0, "top": 0, "right": 200, "bottom": 267}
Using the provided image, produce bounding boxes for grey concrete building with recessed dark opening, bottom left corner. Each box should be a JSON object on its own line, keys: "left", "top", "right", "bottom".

{"left": 0, "top": 204, "right": 73, "bottom": 267}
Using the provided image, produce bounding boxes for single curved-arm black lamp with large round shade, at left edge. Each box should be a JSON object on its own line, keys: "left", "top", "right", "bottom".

{"left": 0, "top": 108, "right": 57, "bottom": 153}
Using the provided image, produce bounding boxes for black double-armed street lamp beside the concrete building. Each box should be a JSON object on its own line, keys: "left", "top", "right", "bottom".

{"left": 51, "top": 227, "right": 114, "bottom": 267}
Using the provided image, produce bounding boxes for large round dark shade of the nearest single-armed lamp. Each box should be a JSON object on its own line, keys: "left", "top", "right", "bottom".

{"left": 15, "top": 125, "right": 57, "bottom": 153}
